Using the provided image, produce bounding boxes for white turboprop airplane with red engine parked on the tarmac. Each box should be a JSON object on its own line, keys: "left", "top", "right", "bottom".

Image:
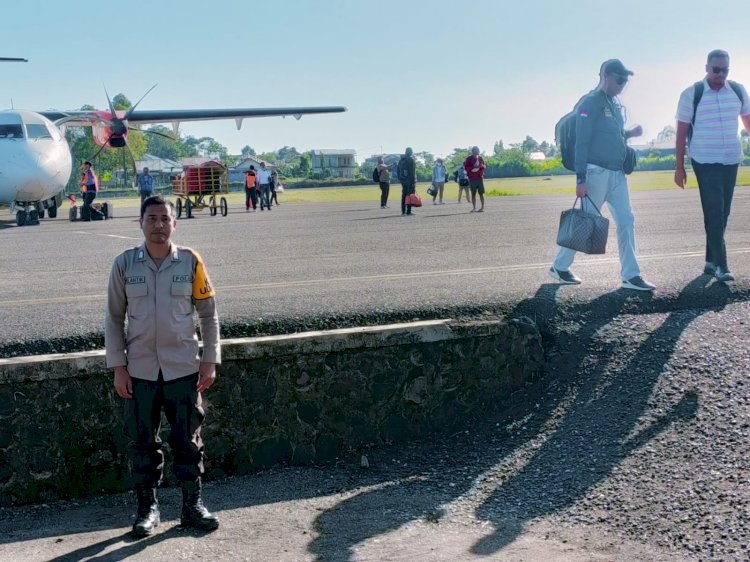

{"left": 0, "top": 63, "right": 346, "bottom": 226}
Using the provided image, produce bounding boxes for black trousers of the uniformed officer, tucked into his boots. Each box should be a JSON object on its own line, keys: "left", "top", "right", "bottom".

{"left": 125, "top": 372, "right": 205, "bottom": 486}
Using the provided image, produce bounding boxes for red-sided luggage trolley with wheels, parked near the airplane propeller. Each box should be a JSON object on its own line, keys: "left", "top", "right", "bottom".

{"left": 172, "top": 160, "right": 229, "bottom": 219}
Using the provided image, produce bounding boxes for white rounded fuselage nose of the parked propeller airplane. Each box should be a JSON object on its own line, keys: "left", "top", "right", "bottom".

{"left": 0, "top": 110, "right": 72, "bottom": 210}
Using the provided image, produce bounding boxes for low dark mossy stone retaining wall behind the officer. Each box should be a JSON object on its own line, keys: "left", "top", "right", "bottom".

{"left": 0, "top": 320, "right": 543, "bottom": 506}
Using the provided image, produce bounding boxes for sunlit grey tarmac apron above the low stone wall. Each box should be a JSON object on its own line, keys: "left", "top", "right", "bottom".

{"left": 0, "top": 189, "right": 750, "bottom": 356}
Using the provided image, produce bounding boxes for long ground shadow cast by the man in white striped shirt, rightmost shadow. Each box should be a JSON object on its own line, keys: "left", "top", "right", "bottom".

{"left": 472, "top": 276, "right": 730, "bottom": 556}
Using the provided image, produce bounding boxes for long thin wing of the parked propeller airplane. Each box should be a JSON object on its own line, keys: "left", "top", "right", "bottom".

{"left": 38, "top": 106, "right": 346, "bottom": 129}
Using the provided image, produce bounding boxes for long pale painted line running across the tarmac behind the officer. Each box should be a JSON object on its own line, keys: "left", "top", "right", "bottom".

{"left": 0, "top": 246, "right": 750, "bottom": 307}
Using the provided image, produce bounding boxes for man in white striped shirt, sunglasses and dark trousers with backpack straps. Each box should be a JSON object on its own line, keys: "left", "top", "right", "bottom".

{"left": 674, "top": 49, "right": 750, "bottom": 282}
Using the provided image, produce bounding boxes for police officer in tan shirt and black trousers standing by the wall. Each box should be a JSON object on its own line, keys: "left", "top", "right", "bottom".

{"left": 105, "top": 195, "right": 221, "bottom": 537}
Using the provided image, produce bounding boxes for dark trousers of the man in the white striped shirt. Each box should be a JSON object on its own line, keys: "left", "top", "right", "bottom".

{"left": 692, "top": 160, "right": 739, "bottom": 271}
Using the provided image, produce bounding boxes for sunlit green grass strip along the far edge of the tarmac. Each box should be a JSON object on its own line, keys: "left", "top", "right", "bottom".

{"left": 106, "top": 167, "right": 750, "bottom": 207}
